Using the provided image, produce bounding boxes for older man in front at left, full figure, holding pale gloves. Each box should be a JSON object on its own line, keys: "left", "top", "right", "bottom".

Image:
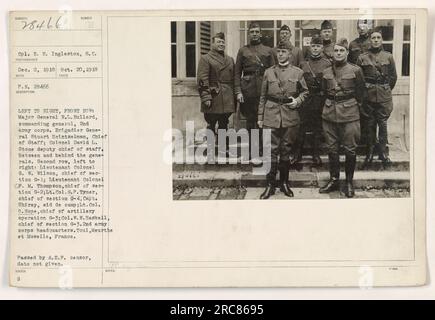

{"left": 258, "top": 41, "right": 307, "bottom": 199}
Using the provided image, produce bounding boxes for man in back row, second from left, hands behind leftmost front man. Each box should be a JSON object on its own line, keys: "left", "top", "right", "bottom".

{"left": 235, "top": 22, "right": 275, "bottom": 158}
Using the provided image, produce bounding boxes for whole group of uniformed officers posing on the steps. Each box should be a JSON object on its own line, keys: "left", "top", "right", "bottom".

{"left": 197, "top": 20, "right": 397, "bottom": 199}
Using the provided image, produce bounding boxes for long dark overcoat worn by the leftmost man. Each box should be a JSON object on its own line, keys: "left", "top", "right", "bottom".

{"left": 197, "top": 50, "right": 240, "bottom": 131}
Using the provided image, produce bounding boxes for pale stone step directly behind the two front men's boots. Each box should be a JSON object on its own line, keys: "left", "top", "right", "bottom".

{"left": 173, "top": 170, "right": 410, "bottom": 189}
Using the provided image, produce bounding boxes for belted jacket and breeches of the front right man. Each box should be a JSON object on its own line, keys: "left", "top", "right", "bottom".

{"left": 322, "top": 62, "right": 365, "bottom": 156}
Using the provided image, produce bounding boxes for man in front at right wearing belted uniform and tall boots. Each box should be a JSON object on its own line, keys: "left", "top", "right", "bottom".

{"left": 319, "top": 38, "right": 366, "bottom": 198}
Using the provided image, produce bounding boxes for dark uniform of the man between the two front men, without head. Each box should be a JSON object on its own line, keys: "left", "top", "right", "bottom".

{"left": 296, "top": 56, "right": 331, "bottom": 159}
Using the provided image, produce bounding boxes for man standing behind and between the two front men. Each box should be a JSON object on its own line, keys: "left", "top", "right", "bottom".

{"left": 290, "top": 35, "right": 331, "bottom": 165}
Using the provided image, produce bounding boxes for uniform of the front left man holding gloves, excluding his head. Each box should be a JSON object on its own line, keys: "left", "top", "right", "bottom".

{"left": 258, "top": 64, "right": 308, "bottom": 181}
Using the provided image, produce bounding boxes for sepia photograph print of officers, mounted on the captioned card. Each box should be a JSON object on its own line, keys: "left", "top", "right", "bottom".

{"left": 171, "top": 17, "right": 413, "bottom": 200}
